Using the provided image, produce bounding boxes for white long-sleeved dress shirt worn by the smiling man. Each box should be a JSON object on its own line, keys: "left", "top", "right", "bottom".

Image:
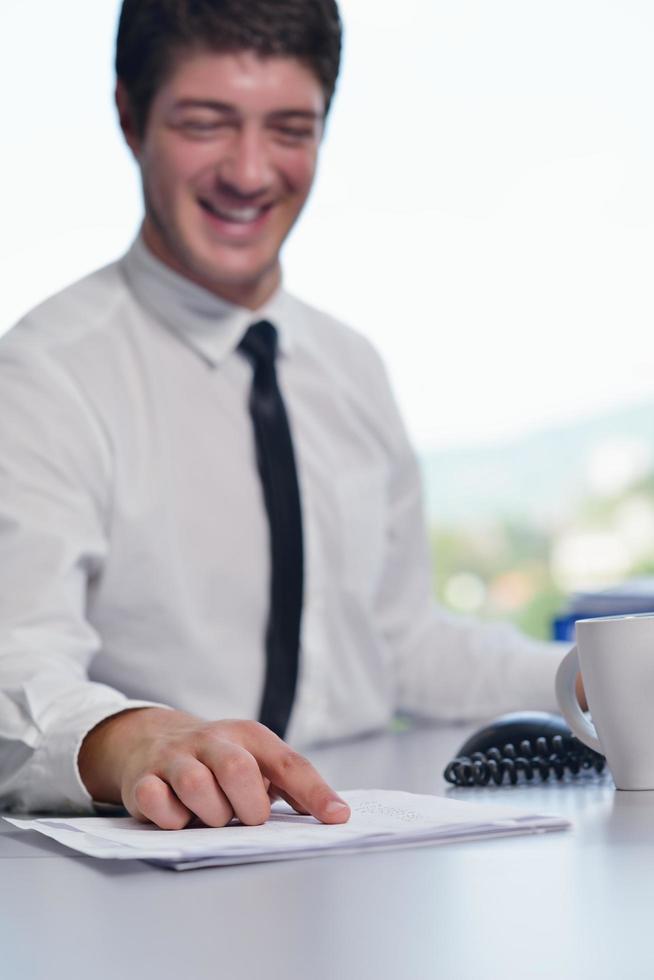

{"left": 0, "top": 240, "right": 561, "bottom": 811}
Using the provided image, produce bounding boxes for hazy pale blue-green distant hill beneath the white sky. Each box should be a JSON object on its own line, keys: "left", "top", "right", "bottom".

{"left": 420, "top": 402, "right": 654, "bottom": 525}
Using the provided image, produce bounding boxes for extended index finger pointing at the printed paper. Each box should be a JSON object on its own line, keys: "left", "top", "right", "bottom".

{"left": 240, "top": 725, "right": 350, "bottom": 823}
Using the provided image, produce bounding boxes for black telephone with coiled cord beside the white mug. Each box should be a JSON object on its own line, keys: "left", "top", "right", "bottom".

{"left": 443, "top": 711, "right": 606, "bottom": 786}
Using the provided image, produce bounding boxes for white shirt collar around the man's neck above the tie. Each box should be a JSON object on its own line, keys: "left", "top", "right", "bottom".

{"left": 121, "top": 236, "right": 293, "bottom": 366}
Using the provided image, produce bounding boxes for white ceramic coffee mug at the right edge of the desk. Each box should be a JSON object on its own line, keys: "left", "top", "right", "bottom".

{"left": 556, "top": 613, "right": 654, "bottom": 790}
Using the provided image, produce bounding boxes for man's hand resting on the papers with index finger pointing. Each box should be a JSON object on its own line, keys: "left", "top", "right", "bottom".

{"left": 78, "top": 708, "right": 350, "bottom": 830}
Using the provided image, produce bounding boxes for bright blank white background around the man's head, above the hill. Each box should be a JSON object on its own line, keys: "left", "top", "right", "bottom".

{"left": 0, "top": 0, "right": 654, "bottom": 448}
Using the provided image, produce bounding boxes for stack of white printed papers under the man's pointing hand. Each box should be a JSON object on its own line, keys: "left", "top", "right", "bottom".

{"left": 5, "top": 790, "right": 570, "bottom": 870}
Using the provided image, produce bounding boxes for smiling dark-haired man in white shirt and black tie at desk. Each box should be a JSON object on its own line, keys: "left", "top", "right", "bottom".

{"left": 0, "top": 0, "right": 559, "bottom": 829}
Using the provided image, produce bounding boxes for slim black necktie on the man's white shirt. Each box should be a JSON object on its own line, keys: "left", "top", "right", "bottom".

{"left": 239, "top": 320, "right": 304, "bottom": 738}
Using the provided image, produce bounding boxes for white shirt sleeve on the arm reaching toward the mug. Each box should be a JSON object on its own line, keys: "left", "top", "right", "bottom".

{"left": 376, "top": 354, "right": 569, "bottom": 720}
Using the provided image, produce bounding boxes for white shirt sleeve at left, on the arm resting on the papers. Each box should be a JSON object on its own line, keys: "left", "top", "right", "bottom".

{"left": 0, "top": 340, "right": 164, "bottom": 812}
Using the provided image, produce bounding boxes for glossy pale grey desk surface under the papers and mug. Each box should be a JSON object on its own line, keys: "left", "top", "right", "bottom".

{"left": 0, "top": 728, "right": 654, "bottom": 980}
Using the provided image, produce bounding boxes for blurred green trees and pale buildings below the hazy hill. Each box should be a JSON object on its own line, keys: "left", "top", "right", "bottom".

{"left": 432, "top": 472, "right": 654, "bottom": 639}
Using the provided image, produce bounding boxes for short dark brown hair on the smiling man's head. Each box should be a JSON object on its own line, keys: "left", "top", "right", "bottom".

{"left": 116, "top": 0, "right": 342, "bottom": 135}
